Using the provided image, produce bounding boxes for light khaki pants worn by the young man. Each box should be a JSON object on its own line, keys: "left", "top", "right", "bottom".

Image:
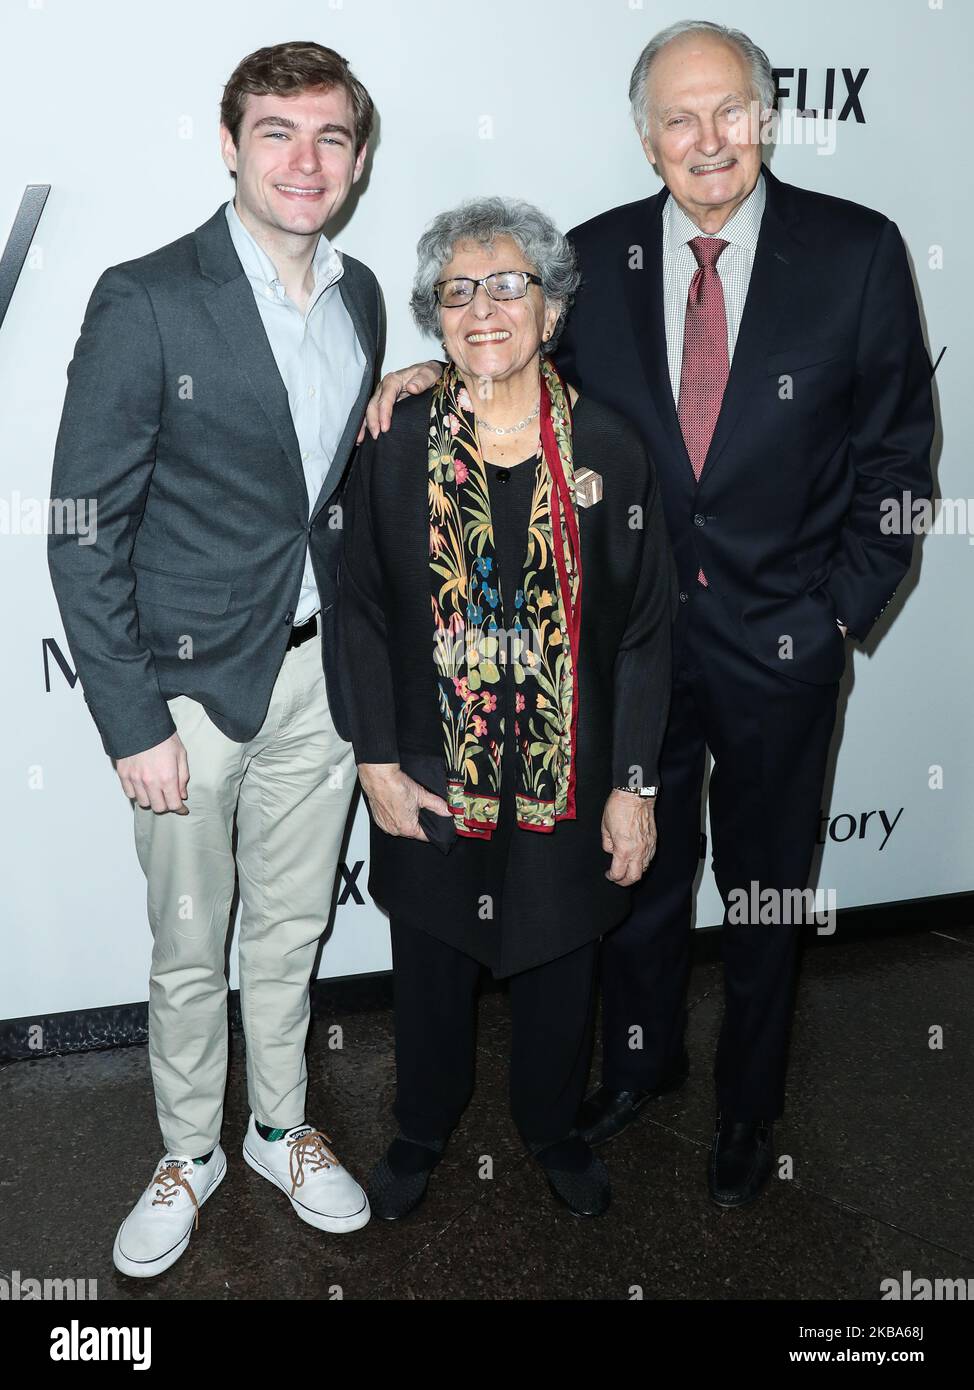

{"left": 135, "top": 638, "right": 356, "bottom": 1158}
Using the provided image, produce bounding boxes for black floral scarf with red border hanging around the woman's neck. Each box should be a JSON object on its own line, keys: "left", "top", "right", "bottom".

{"left": 429, "top": 359, "right": 582, "bottom": 840}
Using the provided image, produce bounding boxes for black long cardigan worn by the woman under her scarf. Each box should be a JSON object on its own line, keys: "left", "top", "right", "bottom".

{"left": 336, "top": 391, "right": 675, "bottom": 976}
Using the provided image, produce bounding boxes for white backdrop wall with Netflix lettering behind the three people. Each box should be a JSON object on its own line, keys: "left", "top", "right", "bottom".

{"left": 0, "top": 0, "right": 974, "bottom": 1019}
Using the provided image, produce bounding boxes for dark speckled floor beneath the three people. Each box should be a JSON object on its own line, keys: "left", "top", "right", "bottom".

{"left": 0, "top": 929, "right": 974, "bottom": 1300}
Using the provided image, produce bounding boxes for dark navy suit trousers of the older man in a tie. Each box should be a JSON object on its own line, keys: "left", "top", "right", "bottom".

{"left": 602, "top": 584, "right": 841, "bottom": 1120}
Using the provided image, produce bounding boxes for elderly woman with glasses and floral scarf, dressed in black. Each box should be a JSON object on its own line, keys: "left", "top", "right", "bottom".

{"left": 338, "top": 197, "right": 671, "bottom": 1219}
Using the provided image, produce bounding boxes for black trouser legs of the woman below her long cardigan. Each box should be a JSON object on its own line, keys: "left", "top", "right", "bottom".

{"left": 390, "top": 917, "right": 599, "bottom": 1150}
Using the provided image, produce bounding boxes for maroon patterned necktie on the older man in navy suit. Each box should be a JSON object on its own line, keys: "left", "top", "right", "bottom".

{"left": 677, "top": 236, "right": 731, "bottom": 584}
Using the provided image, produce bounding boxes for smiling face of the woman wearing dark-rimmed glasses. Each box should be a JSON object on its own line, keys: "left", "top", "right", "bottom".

{"left": 438, "top": 236, "right": 559, "bottom": 386}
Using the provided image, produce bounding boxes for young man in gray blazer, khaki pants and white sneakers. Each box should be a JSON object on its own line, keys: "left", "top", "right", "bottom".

{"left": 50, "top": 43, "right": 381, "bottom": 1277}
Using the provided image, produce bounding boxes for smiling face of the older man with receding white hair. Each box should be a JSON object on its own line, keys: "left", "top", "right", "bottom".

{"left": 642, "top": 33, "right": 761, "bottom": 232}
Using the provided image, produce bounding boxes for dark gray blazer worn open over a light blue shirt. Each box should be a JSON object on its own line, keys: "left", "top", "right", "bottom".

{"left": 47, "top": 204, "right": 382, "bottom": 758}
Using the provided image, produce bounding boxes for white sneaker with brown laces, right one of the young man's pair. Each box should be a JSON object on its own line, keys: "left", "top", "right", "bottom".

{"left": 243, "top": 1115, "right": 372, "bottom": 1232}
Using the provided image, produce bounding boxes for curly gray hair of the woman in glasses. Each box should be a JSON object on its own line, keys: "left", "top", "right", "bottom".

{"left": 410, "top": 197, "right": 581, "bottom": 352}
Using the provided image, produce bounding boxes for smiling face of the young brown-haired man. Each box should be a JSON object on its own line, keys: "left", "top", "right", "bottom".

{"left": 220, "top": 88, "right": 367, "bottom": 236}
